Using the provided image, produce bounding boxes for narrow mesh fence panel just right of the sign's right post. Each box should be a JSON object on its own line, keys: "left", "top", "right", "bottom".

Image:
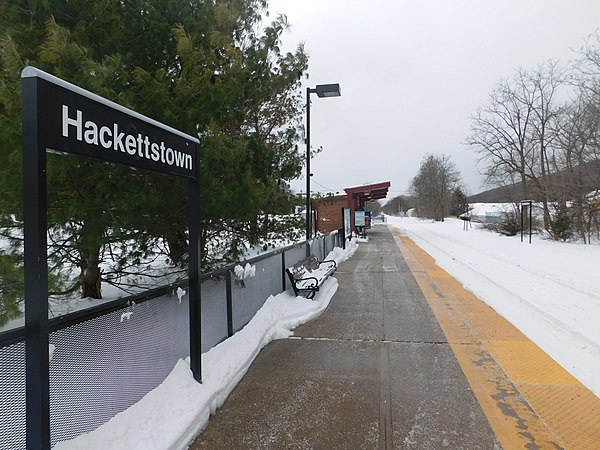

{"left": 202, "top": 278, "right": 227, "bottom": 353}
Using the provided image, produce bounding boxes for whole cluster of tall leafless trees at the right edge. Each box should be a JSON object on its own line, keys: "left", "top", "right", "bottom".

{"left": 466, "top": 33, "right": 600, "bottom": 243}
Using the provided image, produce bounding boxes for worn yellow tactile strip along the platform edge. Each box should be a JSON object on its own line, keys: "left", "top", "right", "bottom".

{"left": 390, "top": 227, "right": 600, "bottom": 450}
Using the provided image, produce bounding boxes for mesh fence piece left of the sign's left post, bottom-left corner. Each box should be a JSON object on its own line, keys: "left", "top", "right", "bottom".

{"left": 0, "top": 342, "right": 25, "bottom": 450}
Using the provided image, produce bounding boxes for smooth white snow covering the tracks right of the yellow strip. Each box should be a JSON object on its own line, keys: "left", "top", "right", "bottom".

{"left": 388, "top": 217, "right": 600, "bottom": 396}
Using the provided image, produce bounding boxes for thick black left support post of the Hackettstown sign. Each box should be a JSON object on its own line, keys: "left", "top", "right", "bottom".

{"left": 21, "top": 73, "right": 50, "bottom": 450}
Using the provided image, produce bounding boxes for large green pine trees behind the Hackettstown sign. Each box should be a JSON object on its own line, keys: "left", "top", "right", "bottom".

{"left": 0, "top": 0, "right": 308, "bottom": 324}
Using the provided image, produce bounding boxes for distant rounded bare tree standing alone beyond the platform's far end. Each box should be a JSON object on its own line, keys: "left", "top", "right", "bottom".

{"left": 410, "top": 154, "right": 461, "bottom": 221}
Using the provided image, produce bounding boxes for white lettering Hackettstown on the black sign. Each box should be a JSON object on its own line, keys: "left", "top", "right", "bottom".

{"left": 62, "top": 104, "right": 193, "bottom": 170}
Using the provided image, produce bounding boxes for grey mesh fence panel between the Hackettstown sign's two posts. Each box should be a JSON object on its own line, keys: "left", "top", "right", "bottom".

{"left": 50, "top": 288, "right": 189, "bottom": 445}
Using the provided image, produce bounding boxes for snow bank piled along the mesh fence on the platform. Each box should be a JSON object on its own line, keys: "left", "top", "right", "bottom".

{"left": 53, "top": 242, "right": 358, "bottom": 450}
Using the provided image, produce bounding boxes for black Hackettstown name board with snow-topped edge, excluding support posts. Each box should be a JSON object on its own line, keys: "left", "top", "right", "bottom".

{"left": 21, "top": 67, "right": 199, "bottom": 179}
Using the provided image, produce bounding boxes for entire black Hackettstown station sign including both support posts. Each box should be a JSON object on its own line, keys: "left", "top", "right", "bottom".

{"left": 21, "top": 67, "right": 201, "bottom": 450}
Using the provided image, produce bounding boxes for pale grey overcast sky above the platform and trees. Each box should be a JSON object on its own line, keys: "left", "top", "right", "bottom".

{"left": 269, "top": 0, "right": 600, "bottom": 199}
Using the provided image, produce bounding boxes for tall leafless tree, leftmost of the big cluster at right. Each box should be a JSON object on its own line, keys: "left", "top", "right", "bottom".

{"left": 466, "top": 61, "right": 564, "bottom": 230}
